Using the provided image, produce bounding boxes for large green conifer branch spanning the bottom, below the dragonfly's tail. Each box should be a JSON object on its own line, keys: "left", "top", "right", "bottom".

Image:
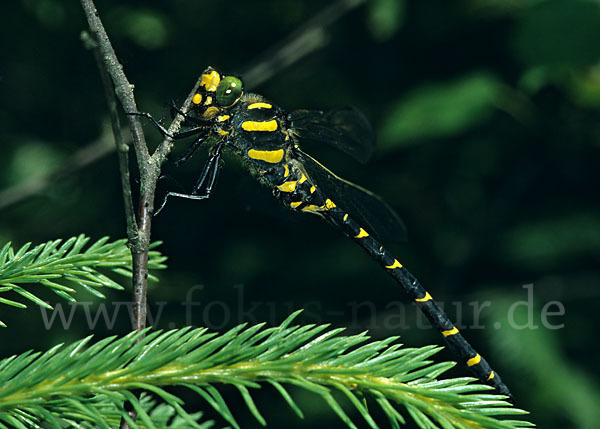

{"left": 0, "top": 312, "right": 533, "bottom": 428}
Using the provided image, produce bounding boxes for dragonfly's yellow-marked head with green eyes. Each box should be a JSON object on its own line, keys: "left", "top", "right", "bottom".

{"left": 192, "top": 67, "right": 244, "bottom": 119}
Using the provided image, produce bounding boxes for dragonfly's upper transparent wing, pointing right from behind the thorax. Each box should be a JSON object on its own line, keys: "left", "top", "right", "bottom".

{"left": 287, "top": 107, "right": 375, "bottom": 163}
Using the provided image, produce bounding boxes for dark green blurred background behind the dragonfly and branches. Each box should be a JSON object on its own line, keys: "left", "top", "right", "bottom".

{"left": 0, "top": 0, "right": 600, "bottom": 428}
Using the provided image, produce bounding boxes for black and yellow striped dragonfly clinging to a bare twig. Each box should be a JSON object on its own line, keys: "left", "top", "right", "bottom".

{"left": 133, "top": 67, "right": 511, "bottom": 397}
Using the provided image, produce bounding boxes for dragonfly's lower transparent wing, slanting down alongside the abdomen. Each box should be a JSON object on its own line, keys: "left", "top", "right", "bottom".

{"left": 298, "top": 151, "right": 406, "bottom": 242}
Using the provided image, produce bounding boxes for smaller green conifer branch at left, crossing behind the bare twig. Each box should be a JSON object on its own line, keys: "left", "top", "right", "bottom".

{"left": 0, "top": 235, "right": 167, "bottom": 326}
